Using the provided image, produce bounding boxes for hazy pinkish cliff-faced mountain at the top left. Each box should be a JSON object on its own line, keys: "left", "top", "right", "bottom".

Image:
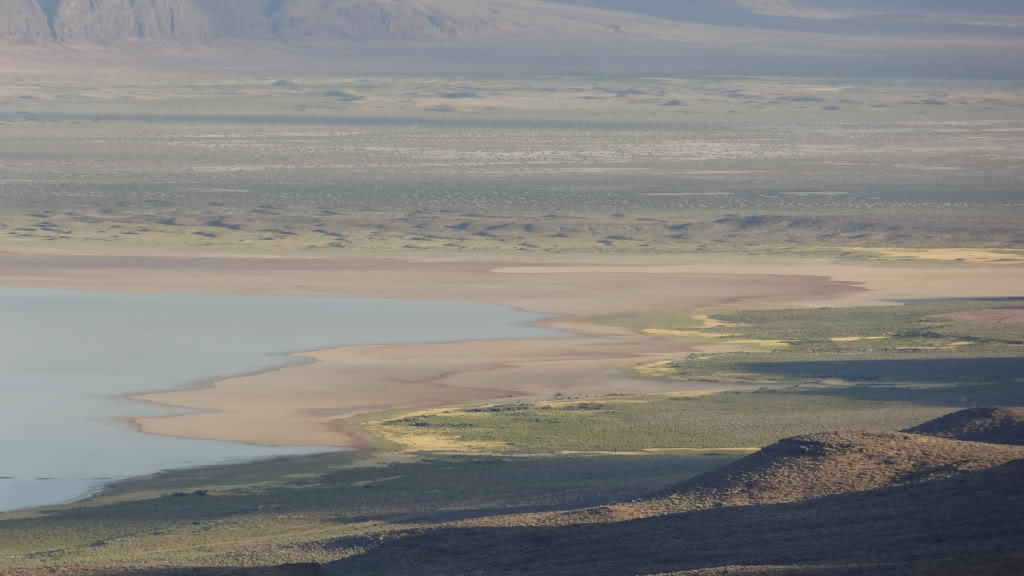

{"left": 0, "top": 0, "right": 498, "bottom": 45}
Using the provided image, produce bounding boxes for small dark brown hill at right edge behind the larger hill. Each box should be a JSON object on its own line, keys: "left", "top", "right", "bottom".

{"left": 904, "top": 408, "right": 1024, "bottom": 446}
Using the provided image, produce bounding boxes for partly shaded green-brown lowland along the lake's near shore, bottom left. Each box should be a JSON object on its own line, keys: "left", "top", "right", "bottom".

{"left": 0, "top": 453, "right": 742, "bottom": 574}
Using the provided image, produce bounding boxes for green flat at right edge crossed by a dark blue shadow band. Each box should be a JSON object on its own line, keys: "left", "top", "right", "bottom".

{"left": 662, "top": 298, "right": 1024, "bottom": 387}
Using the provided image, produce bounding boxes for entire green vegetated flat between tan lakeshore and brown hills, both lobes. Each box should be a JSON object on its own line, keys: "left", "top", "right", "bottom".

{"left": 385, "top": 298, "right": 1024, "bottom": 453}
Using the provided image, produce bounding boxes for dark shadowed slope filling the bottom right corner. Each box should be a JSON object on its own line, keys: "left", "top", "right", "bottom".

{"left": 325, "top": 460, "right": 1024, "bottom": 576}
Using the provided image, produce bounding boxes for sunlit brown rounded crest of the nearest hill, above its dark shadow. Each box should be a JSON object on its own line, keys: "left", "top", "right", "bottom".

{"left": 528, "top": 431, "right": 1024, "bottom": 525}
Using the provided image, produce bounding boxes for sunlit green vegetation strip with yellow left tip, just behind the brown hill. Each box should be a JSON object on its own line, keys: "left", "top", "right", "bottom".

{"left": 385, "top": 389, "right": 949, "bottom": 453}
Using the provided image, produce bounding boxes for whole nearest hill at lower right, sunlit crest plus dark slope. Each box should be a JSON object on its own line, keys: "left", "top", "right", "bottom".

{"left": 315, "top": 424, "right": 1024, "bottom": 576}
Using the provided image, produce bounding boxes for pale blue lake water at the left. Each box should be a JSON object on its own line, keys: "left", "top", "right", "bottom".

{"left": 0, "top": 288, "right": 557, "bottom": 510}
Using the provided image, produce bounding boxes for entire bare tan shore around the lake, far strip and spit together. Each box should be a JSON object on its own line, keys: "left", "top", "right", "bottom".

{"left": 0, "top": 253, "right": 1024, "bottom": 446}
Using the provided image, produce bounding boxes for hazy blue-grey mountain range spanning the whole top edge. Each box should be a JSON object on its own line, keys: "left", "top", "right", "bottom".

{"left": 0, "top": 0, "right": 1024, "bottom": 74}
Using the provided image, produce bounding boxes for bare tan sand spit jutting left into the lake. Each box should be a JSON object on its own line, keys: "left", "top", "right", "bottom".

{"left": 136, "top": 335, "right": 708, "bottom": 446}
